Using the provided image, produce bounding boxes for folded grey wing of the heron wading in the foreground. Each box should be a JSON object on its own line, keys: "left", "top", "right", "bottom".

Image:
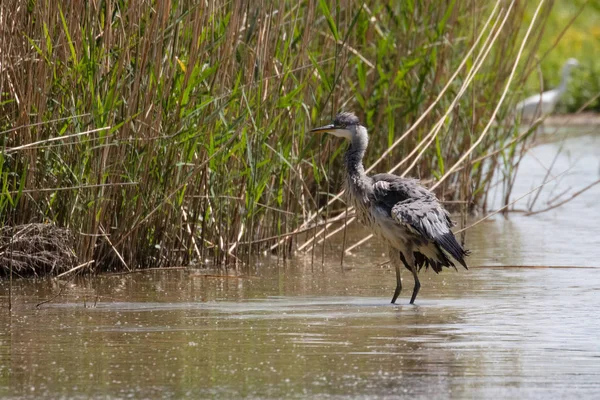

{"left": 391, "top": 200, "right": 468, "bottom": 268}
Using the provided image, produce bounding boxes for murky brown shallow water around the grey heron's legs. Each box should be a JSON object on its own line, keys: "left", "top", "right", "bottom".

{"left": 0, "top": 128, "right": 600, "bottom": 399}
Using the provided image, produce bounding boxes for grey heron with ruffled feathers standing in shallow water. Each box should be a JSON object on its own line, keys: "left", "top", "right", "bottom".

{"left": 311, "top": 112, "right": 469, "bottom": 304}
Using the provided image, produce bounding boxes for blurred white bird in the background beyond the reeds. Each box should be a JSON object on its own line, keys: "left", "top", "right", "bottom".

{"left": 517, "top": 58, "right": 579, "bottom": 121}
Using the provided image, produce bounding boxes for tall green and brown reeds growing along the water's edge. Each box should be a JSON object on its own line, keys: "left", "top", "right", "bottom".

{"left": 0, "top": 0, "right": 552, "bottom": 270}
